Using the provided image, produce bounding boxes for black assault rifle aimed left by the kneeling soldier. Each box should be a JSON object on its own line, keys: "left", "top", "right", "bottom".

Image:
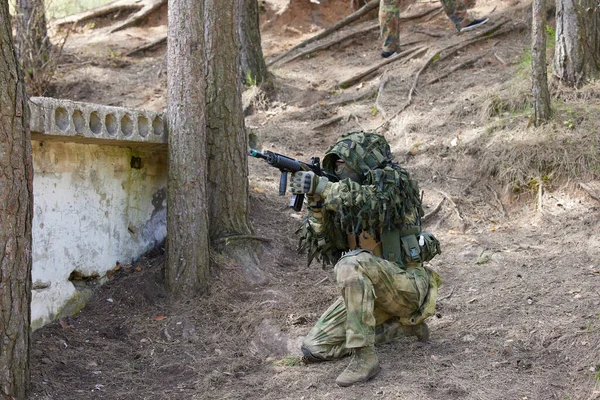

{"left": 248, "top": 149, "right": 338, "bottom": 211}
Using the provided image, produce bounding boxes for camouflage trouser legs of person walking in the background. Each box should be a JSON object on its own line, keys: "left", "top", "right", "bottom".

{"left": 379, "top": 0, "right": 473, "bottom": 53}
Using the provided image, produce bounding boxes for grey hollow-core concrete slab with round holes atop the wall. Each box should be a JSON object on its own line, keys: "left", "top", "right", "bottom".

{"left": 30, "top": 97, "right": 167, "bottom": 147}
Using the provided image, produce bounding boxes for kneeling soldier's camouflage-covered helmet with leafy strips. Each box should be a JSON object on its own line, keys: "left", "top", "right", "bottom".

{"left": 323, "top": 131, "right": 394, "bottom": 178}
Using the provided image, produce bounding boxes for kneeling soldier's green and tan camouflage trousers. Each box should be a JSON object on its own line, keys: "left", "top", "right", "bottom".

{"left": 302, "top": 250, "right": 441, "bottom": 360}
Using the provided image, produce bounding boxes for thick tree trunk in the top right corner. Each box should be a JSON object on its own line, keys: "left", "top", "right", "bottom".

{"left": 554, "top": 0, "right": 600, "bottom": 87}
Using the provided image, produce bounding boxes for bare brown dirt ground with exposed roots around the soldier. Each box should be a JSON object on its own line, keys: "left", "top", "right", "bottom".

{"left": 30, "top": 0, "right": 600, "bottom": 400}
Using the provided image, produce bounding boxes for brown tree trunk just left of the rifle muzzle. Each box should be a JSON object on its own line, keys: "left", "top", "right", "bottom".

{"left": 205, "top": 0, "right": 256, "bottom": 240}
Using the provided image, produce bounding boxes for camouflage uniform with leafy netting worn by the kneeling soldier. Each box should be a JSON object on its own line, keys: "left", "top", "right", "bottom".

{"left": 301, "top": 132, "right": 441, "bottom": 360}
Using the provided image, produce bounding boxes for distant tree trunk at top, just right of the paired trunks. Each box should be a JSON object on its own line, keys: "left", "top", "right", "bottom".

{"left": 238, "top": 0, "right": 269, "bottom": 85}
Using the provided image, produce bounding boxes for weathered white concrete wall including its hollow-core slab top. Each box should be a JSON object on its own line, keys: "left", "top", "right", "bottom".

{"left": 31, "top": 98, "right": 167, "bottom": 329}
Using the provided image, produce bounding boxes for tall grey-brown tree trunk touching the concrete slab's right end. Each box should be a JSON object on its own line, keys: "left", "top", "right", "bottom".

{"left": 165, "top": 0, "right": 210, "bottom": 296}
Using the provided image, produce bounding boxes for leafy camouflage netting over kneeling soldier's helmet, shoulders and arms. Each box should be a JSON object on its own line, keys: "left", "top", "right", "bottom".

{"left": 298, "top": 132, "right": 423, "bottom": 265}
